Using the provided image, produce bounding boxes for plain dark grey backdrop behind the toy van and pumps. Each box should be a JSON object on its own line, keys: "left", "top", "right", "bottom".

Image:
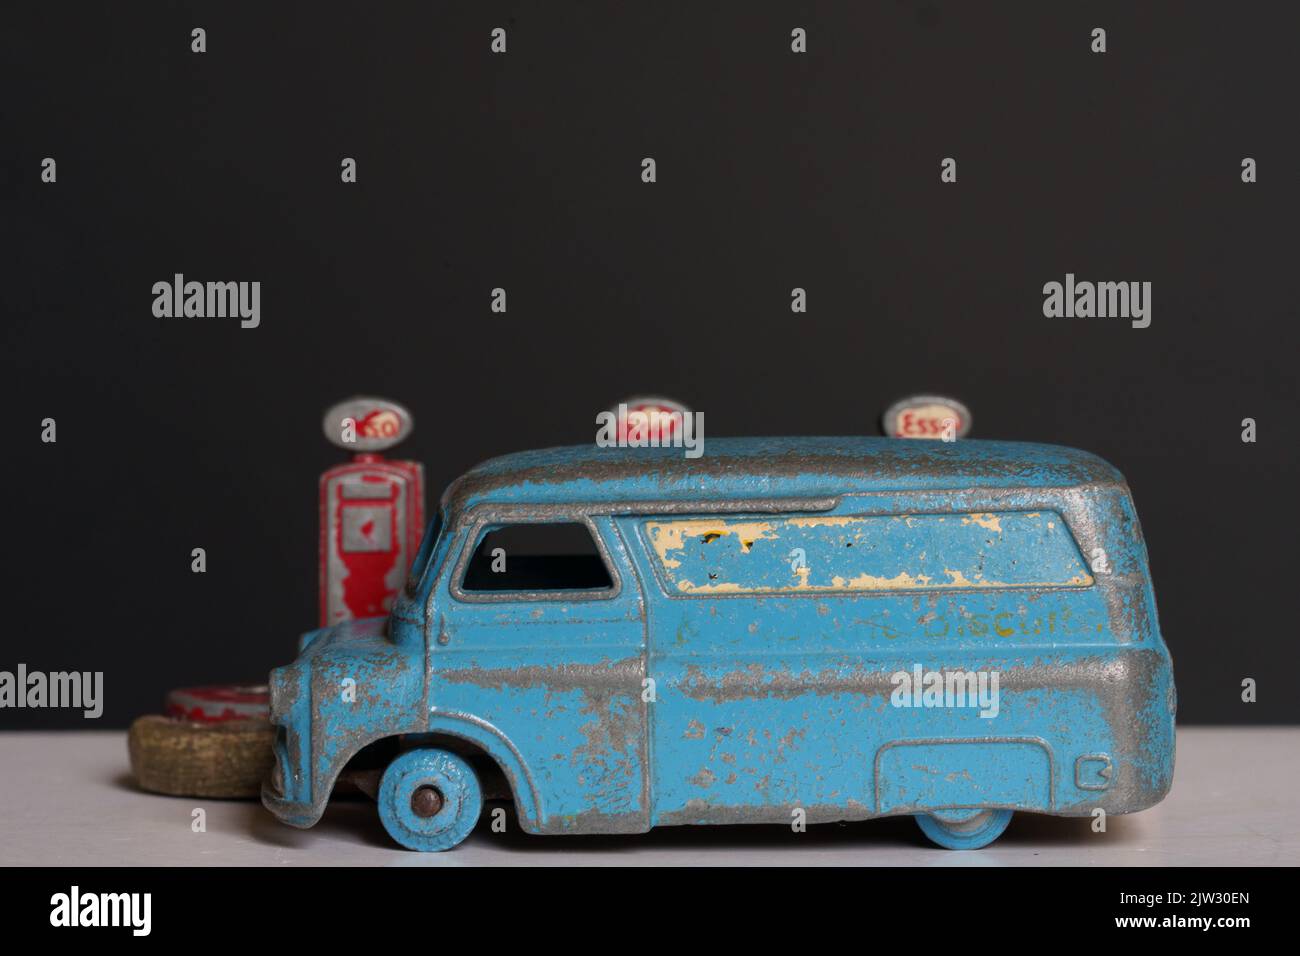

{"left": 0, "top": 0, "right": 1300, "bottom": 727}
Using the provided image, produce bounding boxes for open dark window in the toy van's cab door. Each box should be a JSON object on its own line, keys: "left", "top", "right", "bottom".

{"left": 460, "top": 522, "right": 614, "bottom": 592}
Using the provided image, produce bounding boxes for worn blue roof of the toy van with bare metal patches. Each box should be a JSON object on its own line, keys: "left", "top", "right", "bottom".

{"left": 443, "top": 437, "right": 1123, "bottom": 512}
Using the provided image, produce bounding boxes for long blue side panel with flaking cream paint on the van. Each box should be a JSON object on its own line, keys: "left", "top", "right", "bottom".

{"left": 645, "top": 511, "right": 1093, "bottom": 594}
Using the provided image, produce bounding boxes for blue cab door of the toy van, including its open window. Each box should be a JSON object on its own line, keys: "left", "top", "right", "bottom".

{"left": 430, "top": 510, "right": 650, "bottom": 832}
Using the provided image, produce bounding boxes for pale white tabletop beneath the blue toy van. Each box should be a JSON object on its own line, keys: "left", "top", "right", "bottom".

{"left": 0, "top": 727, "right": 1300, "bottom": 866}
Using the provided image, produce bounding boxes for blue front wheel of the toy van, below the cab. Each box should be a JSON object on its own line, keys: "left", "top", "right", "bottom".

{"left": 378, "top": 749, "right": 484, "bottom": 852}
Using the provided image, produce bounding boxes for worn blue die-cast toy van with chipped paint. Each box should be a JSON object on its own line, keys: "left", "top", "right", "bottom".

{"left": 263, "top": 438, "right": 1175, "bottom": 851}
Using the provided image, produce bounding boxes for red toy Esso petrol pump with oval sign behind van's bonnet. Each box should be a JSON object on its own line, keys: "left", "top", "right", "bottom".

{"left": 320, "top": 398, "right": 424, "bottom": 627}
